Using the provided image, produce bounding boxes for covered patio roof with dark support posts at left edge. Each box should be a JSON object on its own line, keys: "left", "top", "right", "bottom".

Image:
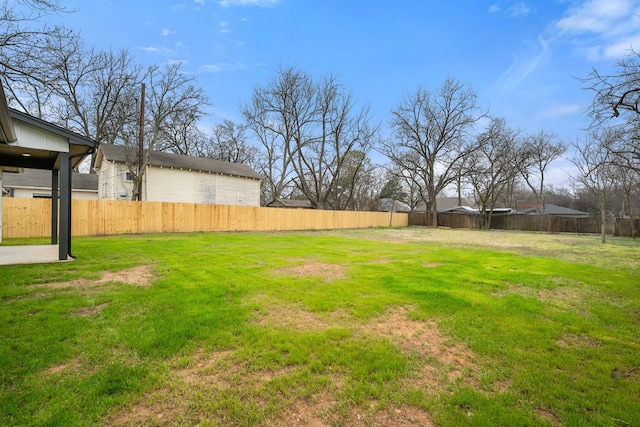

{"left": 0, "top": 84, "right": 96, "bottom": 264}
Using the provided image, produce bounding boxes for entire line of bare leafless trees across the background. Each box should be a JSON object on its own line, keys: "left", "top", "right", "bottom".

{"left": 0, "top": 0, "right": 640, "bottom": 236}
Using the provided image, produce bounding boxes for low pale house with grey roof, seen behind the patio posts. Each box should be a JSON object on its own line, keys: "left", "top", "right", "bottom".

{"left": 2, "top": 169, "right": 98, "bottom": 200}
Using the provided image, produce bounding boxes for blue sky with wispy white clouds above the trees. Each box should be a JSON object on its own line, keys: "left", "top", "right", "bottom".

{"left": 51, "top": 0, "right": 640, "bottom": 184}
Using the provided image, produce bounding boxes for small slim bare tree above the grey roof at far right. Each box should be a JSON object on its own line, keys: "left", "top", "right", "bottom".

{"left": 520, "top": 130, "right": 567, "bottom": 210}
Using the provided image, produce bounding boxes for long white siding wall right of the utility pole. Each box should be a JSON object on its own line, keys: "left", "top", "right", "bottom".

{"left": 143, "top": 167, "right": 260, "bottom": 206}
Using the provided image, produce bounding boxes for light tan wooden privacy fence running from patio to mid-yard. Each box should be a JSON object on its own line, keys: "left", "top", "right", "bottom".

{"left": 2, "top": 197, "right": 408, "bottom": 238}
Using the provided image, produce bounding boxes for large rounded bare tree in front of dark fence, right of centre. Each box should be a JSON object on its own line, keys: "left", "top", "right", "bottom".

{"left": 382, "top": 78, "right": 483, "bottom": 227}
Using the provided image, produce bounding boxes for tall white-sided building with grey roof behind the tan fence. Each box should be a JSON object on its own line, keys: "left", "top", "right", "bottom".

{"left": 94, "top": 144, "right": 261, "bottom": 206}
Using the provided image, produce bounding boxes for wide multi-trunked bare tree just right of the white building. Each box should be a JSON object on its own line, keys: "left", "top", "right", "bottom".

{"left": 242, "top": 68, "right": 377, "bottom": 209}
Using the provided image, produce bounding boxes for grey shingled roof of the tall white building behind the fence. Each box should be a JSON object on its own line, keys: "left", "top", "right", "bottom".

{"left": 96, "top": 144, "right": 262, "bottom": 179}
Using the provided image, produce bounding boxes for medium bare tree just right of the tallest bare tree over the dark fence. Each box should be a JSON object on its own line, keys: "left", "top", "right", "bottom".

{"left": 465, "top": 119, "right": 527, "bottom": 229}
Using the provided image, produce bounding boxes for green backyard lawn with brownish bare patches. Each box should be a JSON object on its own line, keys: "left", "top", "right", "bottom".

{"left": 0, "top": 228, "right": 640, "bottom": 426}
